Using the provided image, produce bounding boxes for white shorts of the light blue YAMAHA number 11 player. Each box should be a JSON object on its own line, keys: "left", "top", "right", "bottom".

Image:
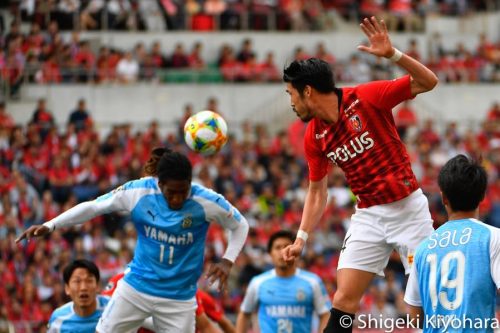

{"left": 96, "top": 280, "right": 196, "bottom": 333}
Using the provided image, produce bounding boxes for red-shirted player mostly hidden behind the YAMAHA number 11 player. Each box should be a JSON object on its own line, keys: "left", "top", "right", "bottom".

{"left": 101, "top": 273, "right": 235, "bottom": 333}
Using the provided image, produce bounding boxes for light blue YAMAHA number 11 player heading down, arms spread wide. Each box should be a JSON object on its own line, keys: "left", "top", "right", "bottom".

{"left": 17, "top": 148, "right": 248, "bottom": 333}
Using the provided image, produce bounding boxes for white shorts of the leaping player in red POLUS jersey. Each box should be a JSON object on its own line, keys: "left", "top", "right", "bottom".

{"left": 337, "top": 189, "right": 434, "bottom": 276}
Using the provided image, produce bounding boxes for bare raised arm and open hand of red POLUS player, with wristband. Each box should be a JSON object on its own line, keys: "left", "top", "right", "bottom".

{"left": 358, "top": 16, "right": 438, "bottom": 96}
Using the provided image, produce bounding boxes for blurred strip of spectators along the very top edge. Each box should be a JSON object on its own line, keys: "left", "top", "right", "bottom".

{"left": 1, "top": 0, "right": 500, "bottom": 31}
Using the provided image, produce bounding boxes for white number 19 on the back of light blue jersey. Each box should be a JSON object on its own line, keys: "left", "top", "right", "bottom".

{"left": 427, "top": 251, "right": 465, "bottom": 310}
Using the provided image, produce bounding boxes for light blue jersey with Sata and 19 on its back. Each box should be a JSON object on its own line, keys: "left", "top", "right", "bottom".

{"left": 405, "top": 219, "right": 500, "bottom": 332}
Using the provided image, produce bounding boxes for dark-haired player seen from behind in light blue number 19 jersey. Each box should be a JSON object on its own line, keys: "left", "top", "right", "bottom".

{"left": 405, "top": 155, "right": 500, "bottom": 332}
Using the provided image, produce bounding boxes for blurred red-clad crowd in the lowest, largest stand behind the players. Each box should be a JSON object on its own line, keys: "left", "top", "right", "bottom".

{"left": 0, "top": 98, "right": 500, "bottom": 332}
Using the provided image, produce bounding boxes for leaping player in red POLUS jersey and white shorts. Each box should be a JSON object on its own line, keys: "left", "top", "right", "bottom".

{"left": 283, "top": 17, "right": 438, "bottom": 332}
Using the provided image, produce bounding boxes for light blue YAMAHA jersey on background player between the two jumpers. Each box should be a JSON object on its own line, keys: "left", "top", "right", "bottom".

{"left": 241, "top": 269, "right": 331, "bottom": 333}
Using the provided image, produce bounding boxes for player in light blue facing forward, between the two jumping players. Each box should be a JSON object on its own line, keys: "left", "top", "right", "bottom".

{"left": 236, "top": 231, "right": 331, "bottom": 333}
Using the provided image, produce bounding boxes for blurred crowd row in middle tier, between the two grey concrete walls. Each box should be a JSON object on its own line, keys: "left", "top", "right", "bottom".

{"left": 0, "top": 20, "right": 500, "bottom": 97}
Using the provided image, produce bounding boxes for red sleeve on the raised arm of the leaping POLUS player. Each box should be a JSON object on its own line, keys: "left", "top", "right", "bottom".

{"left": 358, "top": 75, "right": 414, "bottom": 112}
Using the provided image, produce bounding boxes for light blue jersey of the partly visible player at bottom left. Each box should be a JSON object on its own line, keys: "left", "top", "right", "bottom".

{"left": 47, "top": 295, "right": 109, "bottom": 333}
